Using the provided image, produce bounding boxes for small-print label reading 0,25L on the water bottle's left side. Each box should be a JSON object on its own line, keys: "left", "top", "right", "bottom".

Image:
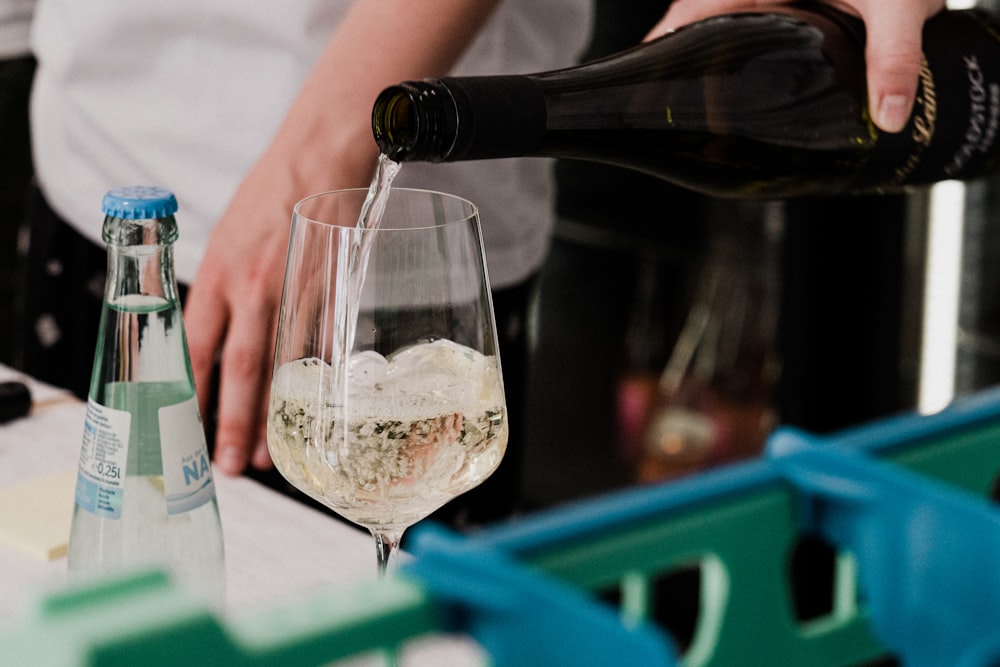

{"left": 76, "top": 401, "right": 132, "bottom": 519}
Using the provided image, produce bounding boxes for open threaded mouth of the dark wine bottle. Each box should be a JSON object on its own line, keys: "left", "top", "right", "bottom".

{"left": 372, "top": 79, "right": 455, "bottom": 162}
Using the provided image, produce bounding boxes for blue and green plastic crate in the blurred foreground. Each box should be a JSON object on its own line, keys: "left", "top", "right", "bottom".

{"left": 0, "top": 392, "right": 1000, "bottom": 667}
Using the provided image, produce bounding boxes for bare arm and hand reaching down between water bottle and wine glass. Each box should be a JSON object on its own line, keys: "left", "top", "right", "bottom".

{"left": 185, "top": 0, "right": 499, "bottom": 474}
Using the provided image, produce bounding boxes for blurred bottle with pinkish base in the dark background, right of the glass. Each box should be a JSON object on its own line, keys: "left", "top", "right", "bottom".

{"left": 636, "top": 201, "right": 782, "bottom": 482}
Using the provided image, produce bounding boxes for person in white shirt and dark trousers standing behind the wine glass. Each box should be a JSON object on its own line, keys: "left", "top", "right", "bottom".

{"left": 26, "top": 0, "right": 590, "bottom": 520}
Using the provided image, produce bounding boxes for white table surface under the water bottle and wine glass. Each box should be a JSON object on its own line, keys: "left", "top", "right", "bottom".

{"left": 0, "top": 365, "right": 482, "bottom": 664}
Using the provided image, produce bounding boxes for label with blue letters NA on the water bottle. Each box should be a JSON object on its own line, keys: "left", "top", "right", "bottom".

{"left": 159, "top": 397, "right": 215, "bottom": 514}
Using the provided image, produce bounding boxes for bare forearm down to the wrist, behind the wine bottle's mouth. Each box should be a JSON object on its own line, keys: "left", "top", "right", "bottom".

{"left": 265, "top": 0, "right": 499, "bottom": 194}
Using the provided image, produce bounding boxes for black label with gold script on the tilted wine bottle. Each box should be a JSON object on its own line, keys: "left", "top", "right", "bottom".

{"left": 859, "top": 11, "right": 1000, "bottom": 186}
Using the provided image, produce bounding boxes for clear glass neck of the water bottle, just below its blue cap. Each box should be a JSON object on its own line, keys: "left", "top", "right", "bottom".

{"left": 103, "top": 216, "right": 178, "bottom": 303}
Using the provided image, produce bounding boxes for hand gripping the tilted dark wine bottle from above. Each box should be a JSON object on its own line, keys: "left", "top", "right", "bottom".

{"left": 649, "top": 0, "right": 945, "bottom": 132}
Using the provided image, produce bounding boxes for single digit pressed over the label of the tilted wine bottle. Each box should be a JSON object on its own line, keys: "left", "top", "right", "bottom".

{"left": 859, "top": 0, "right": 930, "bottom": 132}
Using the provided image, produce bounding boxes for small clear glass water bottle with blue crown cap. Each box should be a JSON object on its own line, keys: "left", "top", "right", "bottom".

{"left": 68, "top": 187, "right": 225, "bottom": 607}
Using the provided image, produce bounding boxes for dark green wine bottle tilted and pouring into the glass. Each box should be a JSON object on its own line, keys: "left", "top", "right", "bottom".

{"left": 372, "top": 3, "right": 1000, "bottom": 198}
